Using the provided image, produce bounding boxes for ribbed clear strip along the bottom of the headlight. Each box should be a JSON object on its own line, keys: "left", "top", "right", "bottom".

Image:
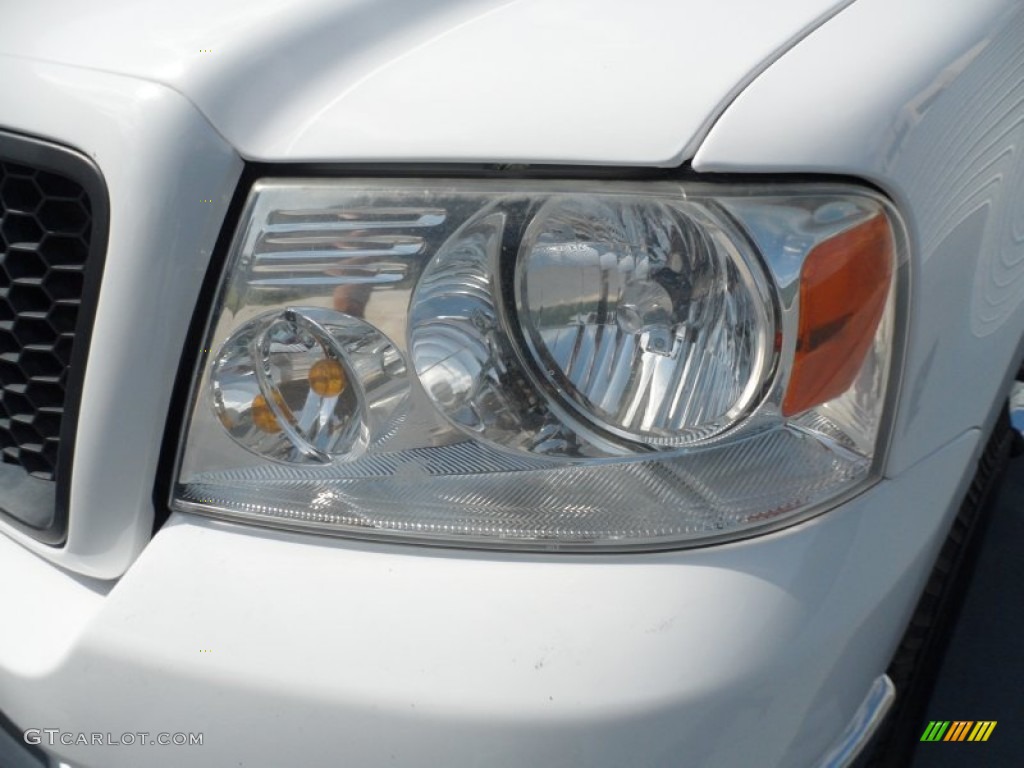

{"left": 176, "top": 429, "right": 869, "bottom": 549}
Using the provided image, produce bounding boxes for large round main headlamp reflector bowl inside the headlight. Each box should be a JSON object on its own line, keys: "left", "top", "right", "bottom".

{"left": 516, "top": 197, "right": 774, "bottom": 445}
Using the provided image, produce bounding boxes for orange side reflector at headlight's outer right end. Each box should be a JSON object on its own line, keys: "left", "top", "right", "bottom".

{"left": 782, "top": 214, "right": 894, "bottom": 416}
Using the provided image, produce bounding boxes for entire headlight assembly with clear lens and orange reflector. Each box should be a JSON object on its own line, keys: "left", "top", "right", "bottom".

{"left": 172, "top": 179, "right": 904, "bottom": 549}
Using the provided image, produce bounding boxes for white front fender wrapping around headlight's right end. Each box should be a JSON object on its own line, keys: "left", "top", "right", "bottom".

{"left": 693, "top": 0, "right": 1024, "bottom": 474}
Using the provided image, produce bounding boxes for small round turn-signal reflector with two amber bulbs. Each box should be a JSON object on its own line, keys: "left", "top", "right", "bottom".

{"left": 211, "top": 308, "right": 408, "bottom": 463}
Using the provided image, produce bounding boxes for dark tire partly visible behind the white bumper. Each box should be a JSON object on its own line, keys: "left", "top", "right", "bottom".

{"left": 857, "top": 409, "right": 1019, "bottom": 768}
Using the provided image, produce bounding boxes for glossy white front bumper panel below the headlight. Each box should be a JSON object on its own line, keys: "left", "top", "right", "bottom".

{"left": 0, "top": 431, "right": 979, "bottom": 768}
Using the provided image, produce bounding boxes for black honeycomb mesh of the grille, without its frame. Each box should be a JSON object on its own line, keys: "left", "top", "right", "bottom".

{"left": 0, "top": 161, "right": 92, "bottom": 480}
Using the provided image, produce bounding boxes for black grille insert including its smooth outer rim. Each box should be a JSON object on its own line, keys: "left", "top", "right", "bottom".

{"left": 0, "top": 130, "right": 110, "bottom": 545}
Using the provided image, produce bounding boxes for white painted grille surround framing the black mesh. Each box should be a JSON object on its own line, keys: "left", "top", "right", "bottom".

{"left": 0, "top": 56, "right": 242, "bottom": 579}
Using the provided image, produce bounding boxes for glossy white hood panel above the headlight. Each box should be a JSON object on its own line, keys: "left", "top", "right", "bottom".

{"left": 2, "top": 0, "right": 849, "bottom": 166}
